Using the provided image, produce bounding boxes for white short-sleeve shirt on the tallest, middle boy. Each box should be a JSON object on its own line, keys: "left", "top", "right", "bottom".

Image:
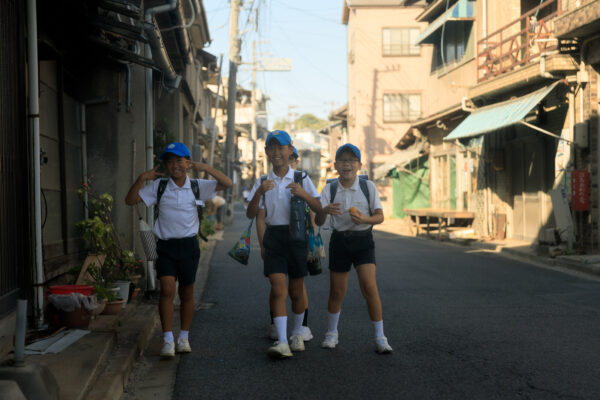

{"left": 248, "top": 168, "right": 319, "bottom": 225}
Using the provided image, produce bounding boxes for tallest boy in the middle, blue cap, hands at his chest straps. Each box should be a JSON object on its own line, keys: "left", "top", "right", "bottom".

{"left": 246, "top": 131, "right": 321, "bottom": 358}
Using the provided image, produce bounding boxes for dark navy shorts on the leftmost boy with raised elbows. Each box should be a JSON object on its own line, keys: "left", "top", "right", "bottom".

{"left": 156, "top": 236, "right": 200, "bottom": 286}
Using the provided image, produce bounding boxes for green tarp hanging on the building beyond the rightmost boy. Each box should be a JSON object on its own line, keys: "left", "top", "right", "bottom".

{"left": 392, "top": 157, "right": 430, "bottom": 218}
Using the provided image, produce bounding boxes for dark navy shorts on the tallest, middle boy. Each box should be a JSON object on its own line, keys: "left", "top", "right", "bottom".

{"left": 263, "top": 225, "right": 308, "bottom": 278}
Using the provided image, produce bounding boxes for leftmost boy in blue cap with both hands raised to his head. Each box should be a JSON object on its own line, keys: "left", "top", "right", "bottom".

{"left": 125, "top": 142, "right": 233, "bottom": 357}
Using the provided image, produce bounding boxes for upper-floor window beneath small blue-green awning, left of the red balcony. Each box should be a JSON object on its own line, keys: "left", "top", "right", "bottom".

{"left": 432, "top": 21, "right": 473, "bottom": 70}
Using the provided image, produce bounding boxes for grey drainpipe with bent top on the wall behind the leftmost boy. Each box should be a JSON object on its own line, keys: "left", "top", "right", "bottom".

{"left": 144, "top": 0, "right": 181, "bottom": 290}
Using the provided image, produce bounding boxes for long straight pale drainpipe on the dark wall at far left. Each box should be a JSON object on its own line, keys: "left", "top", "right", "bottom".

{"left": 27, "top": 0, "right": 44, "bottom": 329}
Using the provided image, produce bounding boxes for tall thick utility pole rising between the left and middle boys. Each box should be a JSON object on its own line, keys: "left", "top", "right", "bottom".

{"left": 225, "top": 0, "right": 243, "bottom": 222}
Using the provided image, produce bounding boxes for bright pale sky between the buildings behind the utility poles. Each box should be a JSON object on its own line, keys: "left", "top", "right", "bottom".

{"left": 204, "top": 0, "right": 348, "bottom": 128}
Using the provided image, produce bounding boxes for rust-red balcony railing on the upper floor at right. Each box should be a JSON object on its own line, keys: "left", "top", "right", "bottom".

{"left": 477, "top": 0, "right": 561, "bottom": 82}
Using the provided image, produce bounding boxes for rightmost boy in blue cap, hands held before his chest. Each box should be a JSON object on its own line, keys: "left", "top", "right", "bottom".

{"left": 316, "top": 143, "right": 392, "bottom": 354}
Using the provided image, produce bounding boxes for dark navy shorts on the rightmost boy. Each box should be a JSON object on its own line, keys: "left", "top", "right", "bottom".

{"left": 329, "top": 229, "right": 375, "bottom": 272}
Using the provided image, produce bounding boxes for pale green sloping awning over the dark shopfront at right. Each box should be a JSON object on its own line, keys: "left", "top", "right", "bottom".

{"left": 444, "top": 82, "right": 560, "bottom": 141}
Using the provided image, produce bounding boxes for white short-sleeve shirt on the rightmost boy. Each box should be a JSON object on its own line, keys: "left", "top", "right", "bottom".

{"left": 321, "top": 176, "right": 382, "bottom": 231}
